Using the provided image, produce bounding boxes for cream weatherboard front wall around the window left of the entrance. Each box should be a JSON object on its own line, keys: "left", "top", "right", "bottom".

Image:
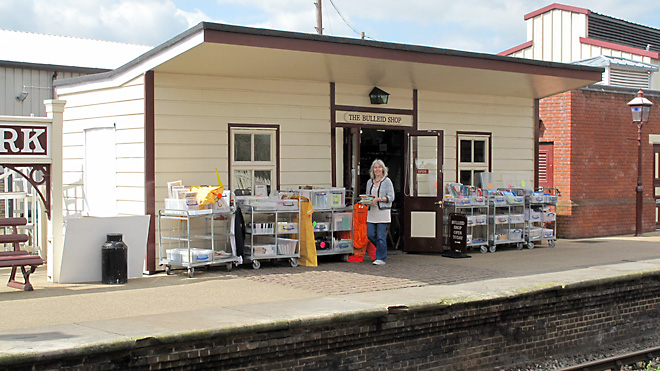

{"left": 155, "top": 73, "right": 332, "bottom": 209}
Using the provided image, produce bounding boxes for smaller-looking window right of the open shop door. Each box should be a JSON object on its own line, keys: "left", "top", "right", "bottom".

{"left": 457, "top": 134, "right": 490, "bottom": 187}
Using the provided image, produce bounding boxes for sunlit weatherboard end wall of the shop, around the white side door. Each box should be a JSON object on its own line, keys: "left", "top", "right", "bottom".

{"left": 59, "top": 76, "right": 145, "bottom": 216}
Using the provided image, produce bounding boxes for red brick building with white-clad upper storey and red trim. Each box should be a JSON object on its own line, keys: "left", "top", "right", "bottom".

{"left": 499, "top": 3, "right": 660, "bottom": 238}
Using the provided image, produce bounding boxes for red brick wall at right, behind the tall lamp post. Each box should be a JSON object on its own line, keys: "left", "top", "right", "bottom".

{"left": 539, "top": 89, "right": 660, "bottom": 238}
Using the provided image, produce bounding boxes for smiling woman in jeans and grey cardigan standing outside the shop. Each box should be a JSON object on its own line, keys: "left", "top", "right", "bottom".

{"left": 367, "top": 159, "right": 394, "bottom": 265}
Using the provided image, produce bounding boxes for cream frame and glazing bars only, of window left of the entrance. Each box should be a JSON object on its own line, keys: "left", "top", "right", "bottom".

{"left": 229, "top": 126, "right": 278, "bottom": 194}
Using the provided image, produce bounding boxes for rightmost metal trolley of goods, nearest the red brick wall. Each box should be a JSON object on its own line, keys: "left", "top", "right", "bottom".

{"left": 525, "top": 188, "right": 560, "bottom": 249}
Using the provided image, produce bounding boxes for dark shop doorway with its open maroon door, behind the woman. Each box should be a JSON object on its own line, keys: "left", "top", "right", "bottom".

{"left": 343, "top": 127, "right": 443, "bottom": 253}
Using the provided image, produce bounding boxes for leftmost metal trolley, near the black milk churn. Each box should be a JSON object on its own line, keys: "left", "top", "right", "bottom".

{"left": 158, "top": 209, "right": 238, "bottom": 278}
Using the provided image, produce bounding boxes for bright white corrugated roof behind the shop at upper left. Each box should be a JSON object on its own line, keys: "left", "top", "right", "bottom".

{"left": 0, "top": 29, "right": 152, "bottom": 69}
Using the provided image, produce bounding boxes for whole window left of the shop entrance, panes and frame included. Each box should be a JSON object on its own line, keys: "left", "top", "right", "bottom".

{"left": 230, "top": 128, "right": 277, "bottom": 194}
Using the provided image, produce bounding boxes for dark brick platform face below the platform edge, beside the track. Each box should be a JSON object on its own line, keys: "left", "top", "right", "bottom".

{"left": 5, "top": 274, "right": 660, "bottom": 371}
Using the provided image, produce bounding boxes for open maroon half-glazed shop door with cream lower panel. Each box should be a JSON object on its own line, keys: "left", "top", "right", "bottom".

{"left": 403, "top": 131, "right": 444, "bottom": 253}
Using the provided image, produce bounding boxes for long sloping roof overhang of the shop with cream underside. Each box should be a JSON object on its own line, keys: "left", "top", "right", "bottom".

{"left": 57, "top": 23, "right": 603, "bottom": 98}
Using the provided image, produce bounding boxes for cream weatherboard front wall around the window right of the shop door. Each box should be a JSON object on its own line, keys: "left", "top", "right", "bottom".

{"left": 418, "top": 91, "right": 535, "bottom": 184}
